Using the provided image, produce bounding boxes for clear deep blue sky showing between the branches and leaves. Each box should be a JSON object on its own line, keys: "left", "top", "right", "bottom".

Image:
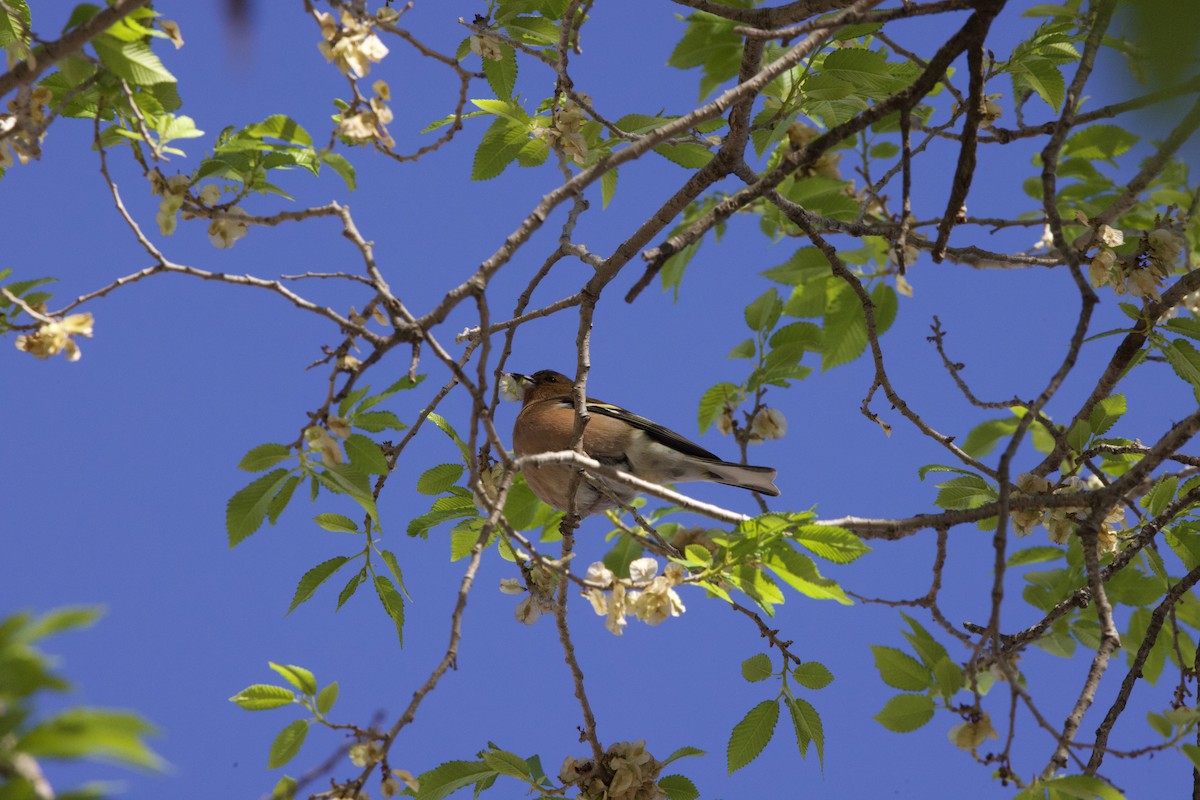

{"left": 0, "top": 1, "right": 1194, "bottom": 800}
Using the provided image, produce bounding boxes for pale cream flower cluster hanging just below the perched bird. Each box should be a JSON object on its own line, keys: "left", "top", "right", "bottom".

{"left": 586, "top": 558, "right": 688, "bottom": 636}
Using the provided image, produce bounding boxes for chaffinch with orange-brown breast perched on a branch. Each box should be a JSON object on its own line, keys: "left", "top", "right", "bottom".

{"left": 509, "top": 369, "right": 779, "bottom": 516}
